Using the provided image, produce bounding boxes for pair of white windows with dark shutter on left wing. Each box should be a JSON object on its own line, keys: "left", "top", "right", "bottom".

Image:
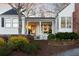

{"left": 1, "top": 18, "right": 18, "bottom": 28}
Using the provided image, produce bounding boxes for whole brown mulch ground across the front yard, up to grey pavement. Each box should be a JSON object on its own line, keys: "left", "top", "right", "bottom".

{"left": 11, "top": 40, "right": 79, "bottom": 56}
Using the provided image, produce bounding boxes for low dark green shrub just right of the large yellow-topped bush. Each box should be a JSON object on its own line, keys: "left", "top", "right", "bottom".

{"left": 22, "top": 43, "right": 40, "bottom": 54}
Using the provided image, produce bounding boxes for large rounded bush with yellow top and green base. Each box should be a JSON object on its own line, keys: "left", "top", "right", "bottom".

{"left": 7, "top": 35, "right": 29, "bottom": 50}
